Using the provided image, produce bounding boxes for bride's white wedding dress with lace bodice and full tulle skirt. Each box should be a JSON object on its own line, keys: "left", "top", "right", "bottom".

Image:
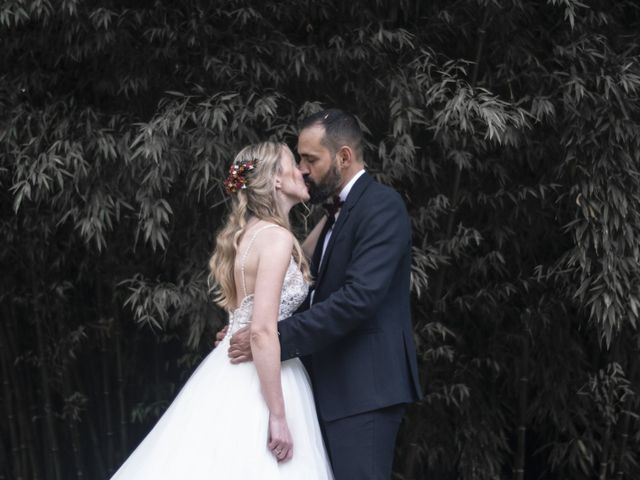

{"left": 111, "top": 225, "right": 333, "bottom": 480}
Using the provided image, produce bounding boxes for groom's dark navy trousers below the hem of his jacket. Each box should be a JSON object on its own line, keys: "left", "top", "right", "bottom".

{"left": 322, "top": 404, "right": 406, "bottom": 480}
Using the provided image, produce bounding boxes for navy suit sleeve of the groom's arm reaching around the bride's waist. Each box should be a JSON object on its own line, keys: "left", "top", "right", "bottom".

{"left": 278, "top": 192, "right": 411, "bottom": 360}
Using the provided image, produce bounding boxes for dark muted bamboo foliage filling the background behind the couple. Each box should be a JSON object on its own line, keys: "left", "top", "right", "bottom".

{"left": 0, "top": 0, "right": 640, "bottom": 480}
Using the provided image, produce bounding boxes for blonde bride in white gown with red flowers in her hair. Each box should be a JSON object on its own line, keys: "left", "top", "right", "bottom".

{"left": 112, "top": 142, "right": 333, "bottom": 480}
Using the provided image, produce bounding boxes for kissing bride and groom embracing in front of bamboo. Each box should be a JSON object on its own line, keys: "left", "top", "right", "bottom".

{"left": 112, "top": 109, "right": 421, "bottom": 480}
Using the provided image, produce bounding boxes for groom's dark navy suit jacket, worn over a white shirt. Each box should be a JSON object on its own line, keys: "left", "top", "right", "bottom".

{"left": 278, "top": 173, "right": 421, "bottom": 421}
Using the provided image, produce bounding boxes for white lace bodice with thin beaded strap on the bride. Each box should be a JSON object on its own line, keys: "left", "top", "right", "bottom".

{"left": 227, "top": 225, "right": 309, "bottom": 336}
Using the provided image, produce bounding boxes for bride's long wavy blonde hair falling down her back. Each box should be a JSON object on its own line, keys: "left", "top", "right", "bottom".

{"left": 209, "top": 142, "right": 311, "bottom": 310}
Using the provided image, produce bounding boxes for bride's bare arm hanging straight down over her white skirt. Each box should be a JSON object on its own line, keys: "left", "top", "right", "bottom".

{"left": 250, "top": 228, "right": 293, "bottom": 460}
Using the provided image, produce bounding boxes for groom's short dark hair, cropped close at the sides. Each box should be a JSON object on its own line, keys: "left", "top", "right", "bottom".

{"left": 300, "top": 108, "right": 364, "bottom": 161}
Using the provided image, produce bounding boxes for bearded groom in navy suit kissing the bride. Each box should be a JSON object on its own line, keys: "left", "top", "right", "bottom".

{"left": 224, "top": 109, "right": 421, "bottom": 480}
